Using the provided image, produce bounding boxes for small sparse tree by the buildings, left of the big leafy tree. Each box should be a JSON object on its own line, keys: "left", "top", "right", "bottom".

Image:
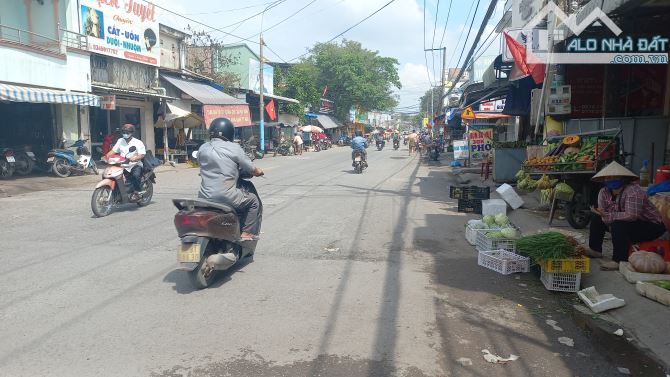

{"left": 186, "top": 26, "right": 240, "bottom": 94}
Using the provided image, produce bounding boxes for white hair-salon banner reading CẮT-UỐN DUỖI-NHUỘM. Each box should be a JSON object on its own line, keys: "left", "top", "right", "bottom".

{"left": 79, "top": 0, "right": 161, "bottom": 66}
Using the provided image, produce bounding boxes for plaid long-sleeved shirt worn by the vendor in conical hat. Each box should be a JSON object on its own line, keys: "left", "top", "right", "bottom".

{"left": 598, "top": 183, "right": 663, "bottom": 224}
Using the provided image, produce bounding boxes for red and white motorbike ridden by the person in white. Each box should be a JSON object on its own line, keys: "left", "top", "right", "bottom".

{"left": 91, "top": 147, "right": 156, "bottom": 217}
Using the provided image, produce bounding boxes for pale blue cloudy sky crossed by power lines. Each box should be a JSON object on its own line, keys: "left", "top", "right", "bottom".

{"left": 155, "top": 0, "right": 504, "bottom": 111}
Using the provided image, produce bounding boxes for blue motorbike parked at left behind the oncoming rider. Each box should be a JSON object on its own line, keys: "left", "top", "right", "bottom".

{"left": 47, "top": 139, "right": 99, "bottom": 178}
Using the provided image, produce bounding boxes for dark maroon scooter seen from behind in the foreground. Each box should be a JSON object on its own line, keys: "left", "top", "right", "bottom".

{"left": 172, "top": 172, "right": 263, "bottom": 289}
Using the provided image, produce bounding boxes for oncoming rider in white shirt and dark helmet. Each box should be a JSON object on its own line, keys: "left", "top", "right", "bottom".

{"left": 106, "top": 123, "right": 147, "bottom": 201}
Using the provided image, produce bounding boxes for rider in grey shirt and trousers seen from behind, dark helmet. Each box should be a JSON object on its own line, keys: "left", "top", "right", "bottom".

{"left": 198, "top": 118, "right": 263, "bottom": 239}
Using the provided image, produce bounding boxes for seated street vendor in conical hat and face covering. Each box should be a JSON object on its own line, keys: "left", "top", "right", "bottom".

{"left": 589, "top": 162, "right": 665, "bottom": 271}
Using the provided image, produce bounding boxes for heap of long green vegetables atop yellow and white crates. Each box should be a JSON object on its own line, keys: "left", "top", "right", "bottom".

{"left": 516, "top": 232, "right": 575, "bottom": 262}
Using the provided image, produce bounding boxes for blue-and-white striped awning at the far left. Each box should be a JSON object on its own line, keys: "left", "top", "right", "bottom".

{"left": 0, "top": 84, "right": 100, "bottom": 107}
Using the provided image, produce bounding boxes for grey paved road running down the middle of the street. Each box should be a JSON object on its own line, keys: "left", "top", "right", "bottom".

{"left": 0, "top": 149, "right": 616, "bottom": 376}
